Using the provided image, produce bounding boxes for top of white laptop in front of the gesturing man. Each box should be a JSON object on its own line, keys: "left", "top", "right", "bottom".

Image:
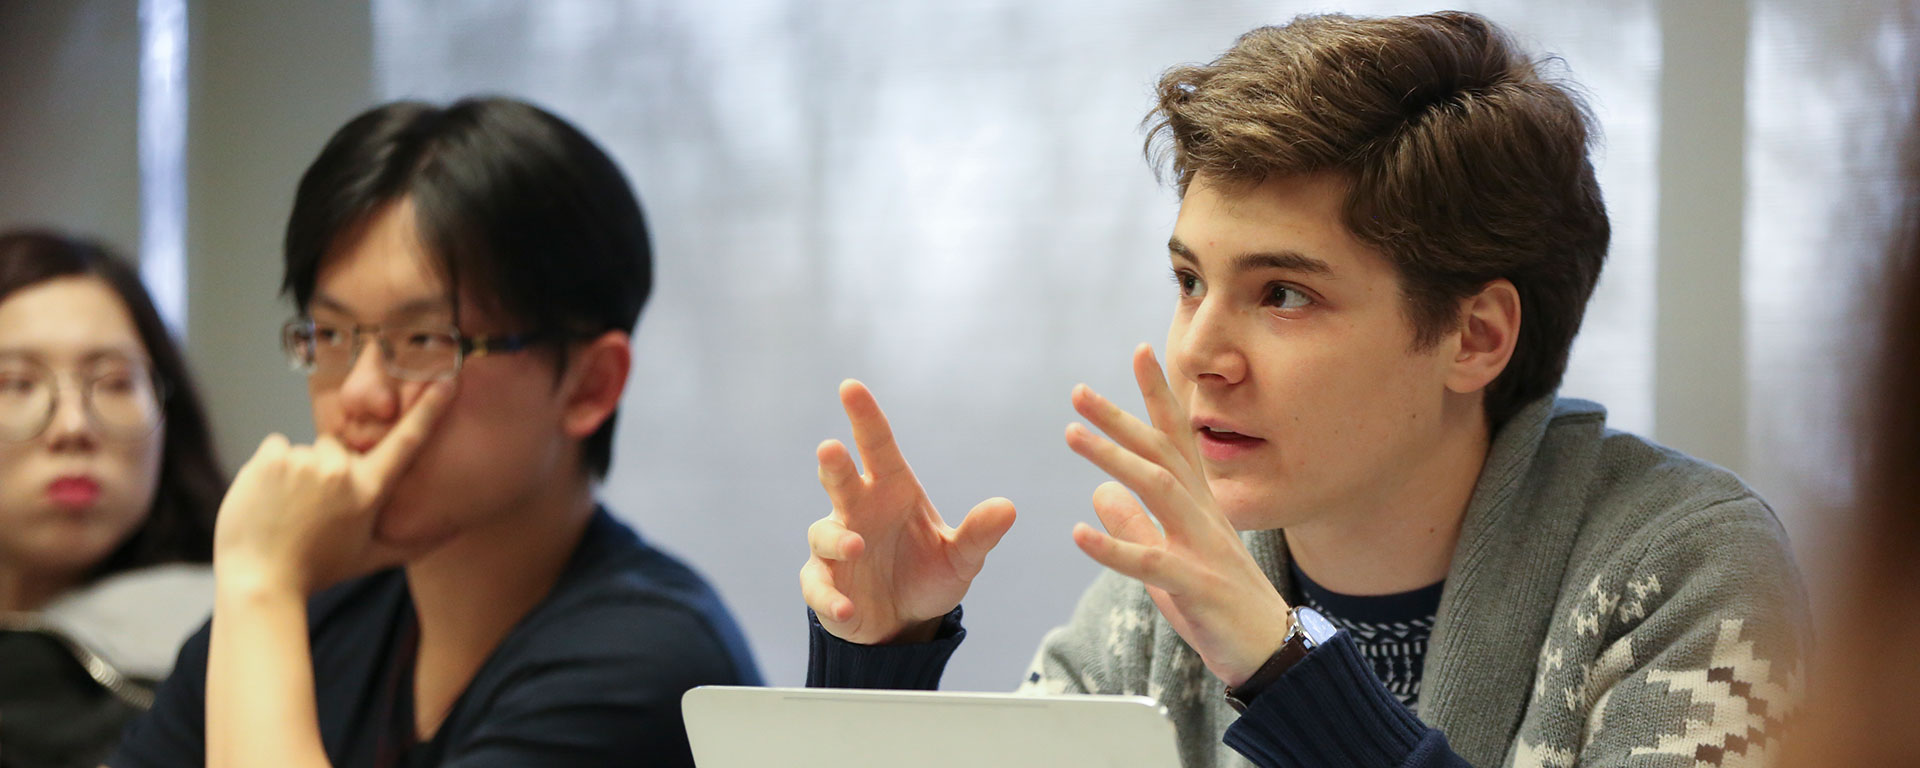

{"left": 680, "top": 685, "right": 1181, "bottom": 768}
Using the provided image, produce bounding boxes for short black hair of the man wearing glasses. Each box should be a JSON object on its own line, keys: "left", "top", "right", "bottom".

{"left": 280, "top": 98, "right": 653, "bottom": 478}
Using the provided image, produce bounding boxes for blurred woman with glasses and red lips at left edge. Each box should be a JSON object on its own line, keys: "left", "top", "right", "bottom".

{"left": 0, "top": 230, "right": 227, "bottom": 766}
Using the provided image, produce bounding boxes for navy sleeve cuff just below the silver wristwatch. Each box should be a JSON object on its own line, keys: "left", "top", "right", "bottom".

{"left": 1223, "top": 632, "right": 1430, "bottom": 768}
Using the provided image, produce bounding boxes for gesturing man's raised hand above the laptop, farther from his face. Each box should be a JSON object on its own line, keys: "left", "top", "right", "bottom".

{"left": 801, "top": 378, "right": 1014, "bottom": 645}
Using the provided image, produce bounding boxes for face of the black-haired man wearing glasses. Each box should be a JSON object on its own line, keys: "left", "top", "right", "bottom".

{"left": 307, "top": 200, "right": 572, "bottom": 551}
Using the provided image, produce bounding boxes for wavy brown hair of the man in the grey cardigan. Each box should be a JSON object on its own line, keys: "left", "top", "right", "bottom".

{"left": 1146, "top": 12, "right": 1611, "bottom": 426}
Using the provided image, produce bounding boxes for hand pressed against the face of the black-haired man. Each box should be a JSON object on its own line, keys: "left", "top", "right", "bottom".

{"left": 213, "top": 382, "right": 453, "bottom": 597}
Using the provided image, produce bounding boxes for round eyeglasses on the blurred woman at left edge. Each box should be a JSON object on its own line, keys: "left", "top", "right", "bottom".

{"left": 0, "top": 357, "right": 167, "bottom": 442}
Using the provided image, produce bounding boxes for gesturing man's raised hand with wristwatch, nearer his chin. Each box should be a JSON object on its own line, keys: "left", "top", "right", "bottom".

{"left": 1068, "top": 344, "right": 1288, "bottom": 685}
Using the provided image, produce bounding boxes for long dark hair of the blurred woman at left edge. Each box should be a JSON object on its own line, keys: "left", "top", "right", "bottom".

{"left": 0, "top": 230, "right": 227, "bottom": 578}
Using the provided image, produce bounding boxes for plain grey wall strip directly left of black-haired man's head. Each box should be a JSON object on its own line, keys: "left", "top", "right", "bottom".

{"left": 186, "top": 0, "right": 372, "bottom": 467}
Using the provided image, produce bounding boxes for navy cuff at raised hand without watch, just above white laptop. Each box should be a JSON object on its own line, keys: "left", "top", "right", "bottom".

{"left": 806, "top": 607, "right": 966, "bottom": 691}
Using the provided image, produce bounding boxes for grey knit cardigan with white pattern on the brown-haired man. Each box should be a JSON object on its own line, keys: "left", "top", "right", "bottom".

{"left": 1013, "top": 397, "right": 1807, "bottom": 768}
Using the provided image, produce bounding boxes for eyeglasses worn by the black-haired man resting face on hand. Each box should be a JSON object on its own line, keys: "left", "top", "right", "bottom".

{"left": 280, "top": 317, "right": 541, "bottom": 382}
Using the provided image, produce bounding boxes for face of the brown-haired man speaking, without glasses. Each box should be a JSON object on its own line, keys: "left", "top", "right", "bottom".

{"left": 1167, "top": 175, "right": 1453, "bottom": 530}
